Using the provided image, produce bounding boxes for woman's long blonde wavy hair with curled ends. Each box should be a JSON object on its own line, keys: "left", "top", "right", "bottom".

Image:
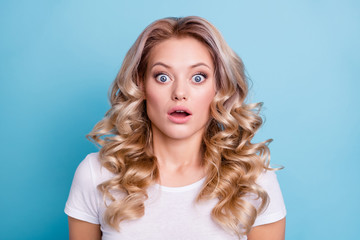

{"left": 87, "top": 16, "right": 271, "bottom": 237}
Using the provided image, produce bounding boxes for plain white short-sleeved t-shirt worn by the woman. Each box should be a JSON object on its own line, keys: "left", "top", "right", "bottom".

{"left": 65, "top": 153, "right": 286, "bottom": 240}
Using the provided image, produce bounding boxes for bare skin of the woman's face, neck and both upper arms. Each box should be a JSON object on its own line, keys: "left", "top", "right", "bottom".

{"left": 68, "top": 37, "right": 285, "bottom": 240}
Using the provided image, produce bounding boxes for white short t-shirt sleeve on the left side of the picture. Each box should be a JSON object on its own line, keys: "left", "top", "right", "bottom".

{"left": 65, "top": 154, "right": 100, "bottom": 224}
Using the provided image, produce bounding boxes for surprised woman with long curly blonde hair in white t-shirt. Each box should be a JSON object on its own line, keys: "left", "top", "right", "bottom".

{"left": 65, "top": 17, "right": 286, "bottom": 240}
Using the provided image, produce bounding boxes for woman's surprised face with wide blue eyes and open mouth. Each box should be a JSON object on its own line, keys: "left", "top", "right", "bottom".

{"left": 144, "top": 37, "right": 216, "bottom": 139}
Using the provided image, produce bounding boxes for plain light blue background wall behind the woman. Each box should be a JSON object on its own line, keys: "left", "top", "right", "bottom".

{"left": 0, "top": 0, "right": 360, "bottom": 240}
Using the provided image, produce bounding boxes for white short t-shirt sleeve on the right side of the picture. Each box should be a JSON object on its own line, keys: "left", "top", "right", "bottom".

{"left": 253, "top": 171, "right": 286, "bottom": 227}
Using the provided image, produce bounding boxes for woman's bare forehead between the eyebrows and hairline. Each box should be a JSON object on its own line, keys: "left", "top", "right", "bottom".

{"left": 148, "top": 37, "right": 214, "bottom": 69}
